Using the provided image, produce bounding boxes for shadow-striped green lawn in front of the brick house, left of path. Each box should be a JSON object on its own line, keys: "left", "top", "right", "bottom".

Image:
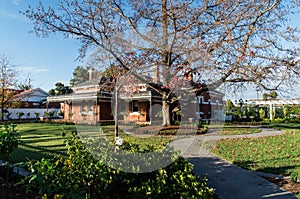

{"left": 10, "top": 123, "right": 172, "bottom": 163}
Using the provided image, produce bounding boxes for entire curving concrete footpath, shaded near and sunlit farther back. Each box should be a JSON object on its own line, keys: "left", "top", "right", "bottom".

{"left": 175, "top": 129, "right": 297, "bottom": 199}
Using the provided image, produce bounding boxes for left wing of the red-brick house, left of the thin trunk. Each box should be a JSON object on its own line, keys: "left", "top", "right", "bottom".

{"left": 47, "top": 79, "right": 113, "bottom": 123}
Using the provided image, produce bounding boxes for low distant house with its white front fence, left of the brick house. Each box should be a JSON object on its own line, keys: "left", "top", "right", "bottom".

{"left": 4, "top": 88, "right": 60, "bottom": 119}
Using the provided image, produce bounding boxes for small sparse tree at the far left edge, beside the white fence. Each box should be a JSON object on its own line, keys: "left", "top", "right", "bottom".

{"left": 0, "top": 53, "right": 18, "bottom": 121}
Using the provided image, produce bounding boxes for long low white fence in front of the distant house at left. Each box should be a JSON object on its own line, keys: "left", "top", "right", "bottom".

{"left": 4, "top": 108, "right": 60, "bottom": 120}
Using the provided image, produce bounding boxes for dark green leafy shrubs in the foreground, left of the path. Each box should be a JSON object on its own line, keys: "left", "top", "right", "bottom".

{"left": 24, "top": 134, "right": 213, "bottom": 198}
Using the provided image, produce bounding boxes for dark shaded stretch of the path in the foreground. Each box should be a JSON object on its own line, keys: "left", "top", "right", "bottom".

{"left": 188, "top": 155, "right": 296, "bottom": 199}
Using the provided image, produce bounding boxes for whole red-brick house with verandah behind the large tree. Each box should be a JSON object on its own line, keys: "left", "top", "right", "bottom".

{"left": 47, "top": 69, "right": 223, "bottom": 123}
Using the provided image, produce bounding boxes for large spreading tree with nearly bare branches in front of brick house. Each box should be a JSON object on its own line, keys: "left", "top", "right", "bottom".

{"left": 24, "top": 0, "right": 299, "bottom": 125}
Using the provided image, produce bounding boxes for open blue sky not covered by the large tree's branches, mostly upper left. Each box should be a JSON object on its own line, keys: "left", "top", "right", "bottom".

{"left": 0, "top": 0, "right": 300, "bottom": 99}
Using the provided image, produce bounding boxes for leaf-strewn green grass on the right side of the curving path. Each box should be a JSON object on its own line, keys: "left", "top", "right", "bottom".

{"left": 212, "top": 128, "right": 300, "bottom": 175}
